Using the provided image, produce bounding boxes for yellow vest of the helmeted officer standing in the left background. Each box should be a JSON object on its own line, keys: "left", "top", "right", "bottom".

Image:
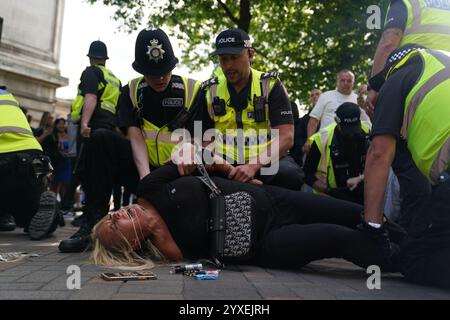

{"left": 71, "top": 65, "right": 121, "bottom": 122}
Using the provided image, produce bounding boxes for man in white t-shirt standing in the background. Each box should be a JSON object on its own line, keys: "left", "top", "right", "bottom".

{"left": 303, "top": 70, "right": 370, "bottom": 153}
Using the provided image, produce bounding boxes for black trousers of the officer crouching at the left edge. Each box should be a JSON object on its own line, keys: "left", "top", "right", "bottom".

{"left": 0, "top": 150, "right": 45, "bottom": 228}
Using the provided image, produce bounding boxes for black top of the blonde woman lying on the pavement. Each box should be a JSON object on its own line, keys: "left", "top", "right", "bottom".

{"left": 137, "top": 165, "right": 282, "bottom": 259}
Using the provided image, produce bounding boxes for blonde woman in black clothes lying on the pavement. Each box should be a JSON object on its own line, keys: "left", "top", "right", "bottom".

{"left": 92, "top": 160, "right": 404, "bottom": 271}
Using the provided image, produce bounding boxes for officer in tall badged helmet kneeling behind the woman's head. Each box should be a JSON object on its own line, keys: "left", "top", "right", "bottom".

{"left": 59, "top": 29, "right": 200, "bottom": 252}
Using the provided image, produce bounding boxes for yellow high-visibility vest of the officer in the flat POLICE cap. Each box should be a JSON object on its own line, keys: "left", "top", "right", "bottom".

{"left": 203, "top": 69, "right": 279, "bottom": 164}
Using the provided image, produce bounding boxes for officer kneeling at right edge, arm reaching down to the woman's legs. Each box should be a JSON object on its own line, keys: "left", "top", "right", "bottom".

{"left": 364, "top": 45, "right": 450, "bottom": 288}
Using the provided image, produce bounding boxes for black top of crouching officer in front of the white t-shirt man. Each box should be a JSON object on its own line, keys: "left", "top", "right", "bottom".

{"left": 303, "top": 130, "right": 369, "bottom": 188}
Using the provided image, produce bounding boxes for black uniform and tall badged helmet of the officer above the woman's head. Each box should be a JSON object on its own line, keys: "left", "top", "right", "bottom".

{"left": 59, "top": 29, "right": 192, "bottom": 252}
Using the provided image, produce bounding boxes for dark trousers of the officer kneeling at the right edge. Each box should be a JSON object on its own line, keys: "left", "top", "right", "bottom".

{"left": 400, "top": 180, "right": 450, "bottom": 288}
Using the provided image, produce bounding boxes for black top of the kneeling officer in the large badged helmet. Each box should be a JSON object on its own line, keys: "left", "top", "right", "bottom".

{"left": 118, "top": 75, "right": 189, "bottom": 134}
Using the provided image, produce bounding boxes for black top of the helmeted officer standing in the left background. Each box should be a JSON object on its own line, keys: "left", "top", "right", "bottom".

{"left": 78, "top": 66, "right": 117, "bottom": 130}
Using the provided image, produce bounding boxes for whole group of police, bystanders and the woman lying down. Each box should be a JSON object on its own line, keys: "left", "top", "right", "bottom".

{"left": 0, "top": 0, "right": 450, "bottom": 288}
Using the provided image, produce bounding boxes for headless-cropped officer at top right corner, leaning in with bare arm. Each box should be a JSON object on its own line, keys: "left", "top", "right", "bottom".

{"left": 367, "top": 0, "right": 450, "bottom": 114}
